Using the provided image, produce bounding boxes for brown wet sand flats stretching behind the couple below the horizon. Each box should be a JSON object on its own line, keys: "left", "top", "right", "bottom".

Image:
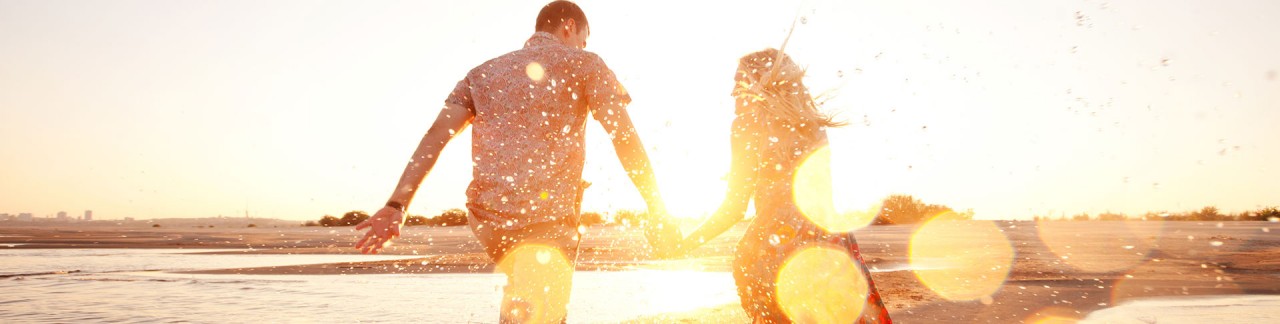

{"left": 0, "top": 222, "right": 1280, "bottom": 323}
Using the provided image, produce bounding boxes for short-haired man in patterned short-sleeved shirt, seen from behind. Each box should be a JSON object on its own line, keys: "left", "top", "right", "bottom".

{"left": 356, "top": 1, "right": 680, "bottom": 323}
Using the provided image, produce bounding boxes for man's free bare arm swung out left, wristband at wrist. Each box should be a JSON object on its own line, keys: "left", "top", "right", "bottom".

{"left": 356, "top": 104, "right": 475, "bottom": 254}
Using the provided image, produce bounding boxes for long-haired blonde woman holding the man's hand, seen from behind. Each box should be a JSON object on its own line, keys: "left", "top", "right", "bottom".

{"left": 680, "top": 49, "right": 891, "bottom": 323}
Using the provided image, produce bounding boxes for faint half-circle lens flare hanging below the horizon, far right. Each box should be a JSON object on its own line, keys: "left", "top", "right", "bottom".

{"left": 1036, "top": 220, "right": 1165, "bottom": 273}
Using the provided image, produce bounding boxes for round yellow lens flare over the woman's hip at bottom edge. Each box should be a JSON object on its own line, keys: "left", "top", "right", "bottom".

{"left": 776, "top": 246, "right": 869, "bottom": 323}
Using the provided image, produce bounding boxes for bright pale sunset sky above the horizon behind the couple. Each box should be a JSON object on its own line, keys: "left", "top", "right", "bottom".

{"left": 0, "top": 0, "right": 1280, "bottom": 220}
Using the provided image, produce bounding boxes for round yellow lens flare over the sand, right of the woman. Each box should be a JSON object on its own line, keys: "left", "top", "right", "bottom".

{"left": 909, "top": 211, "right": 1014, "bottom": 301}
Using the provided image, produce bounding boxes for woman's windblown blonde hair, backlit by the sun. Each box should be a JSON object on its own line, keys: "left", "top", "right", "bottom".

{"left": 733, "top": 49, "right": 845, "bottom": 128}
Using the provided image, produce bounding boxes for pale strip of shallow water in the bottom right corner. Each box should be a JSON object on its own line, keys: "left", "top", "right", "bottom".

{"left": 1080, "top": 295, "right": 1280, "bottom": 324}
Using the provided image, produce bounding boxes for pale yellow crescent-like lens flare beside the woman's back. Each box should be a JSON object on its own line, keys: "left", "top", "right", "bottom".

{"left": 791, "top": 146, "right": 879, "bottom": 233}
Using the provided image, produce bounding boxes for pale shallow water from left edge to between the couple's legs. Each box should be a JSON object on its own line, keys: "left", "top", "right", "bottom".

{"left": 0, "top": 248, "right": 737, "bottom": 323}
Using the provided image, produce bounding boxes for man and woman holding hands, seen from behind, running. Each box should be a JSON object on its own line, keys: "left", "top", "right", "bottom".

{"left": 356, "top": 0, "right": 891, "bottom": 323}
